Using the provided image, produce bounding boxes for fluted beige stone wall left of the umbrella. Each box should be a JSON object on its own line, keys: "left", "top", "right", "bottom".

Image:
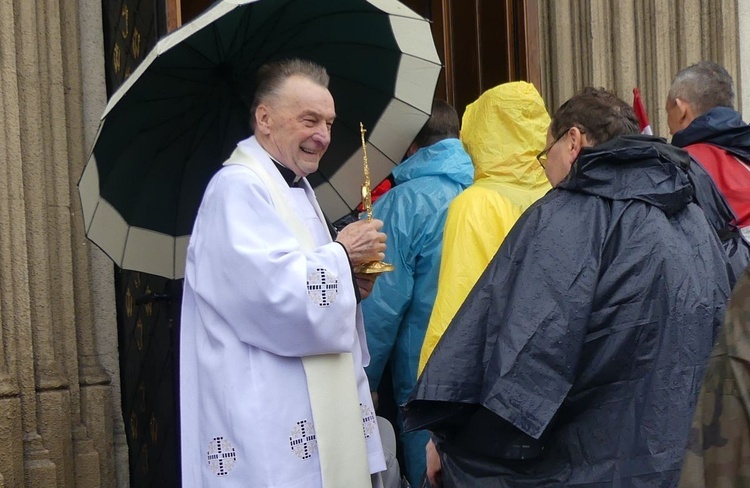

{"left": 0, "top": 0, "right": 127, "bottom": 487}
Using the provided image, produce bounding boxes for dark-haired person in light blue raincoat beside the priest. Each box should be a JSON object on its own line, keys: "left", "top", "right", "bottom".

{"left": 362, "top": 100, "right": 474, "bottom": 486}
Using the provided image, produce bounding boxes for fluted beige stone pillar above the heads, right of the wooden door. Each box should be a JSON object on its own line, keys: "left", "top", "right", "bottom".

{"left": 539, "top": 0, "right": 750, "bottom": 136}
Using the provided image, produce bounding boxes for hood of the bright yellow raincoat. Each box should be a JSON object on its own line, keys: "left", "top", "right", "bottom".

{"left": 461, "top": 81, "right": 550, "bottom": 188}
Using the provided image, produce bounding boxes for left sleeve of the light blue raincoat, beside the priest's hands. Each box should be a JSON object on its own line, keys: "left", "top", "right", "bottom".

{"left": 362, "top": 187, "right": 418, "bottom": 391}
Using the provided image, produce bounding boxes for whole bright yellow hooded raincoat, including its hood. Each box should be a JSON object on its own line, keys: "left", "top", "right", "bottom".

{"left": 419, "top": 81, "right": 551, "bottom": 374}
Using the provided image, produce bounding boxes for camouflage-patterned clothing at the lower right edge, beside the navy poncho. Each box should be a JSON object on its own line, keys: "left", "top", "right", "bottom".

{"left": 680, "top": 268, "right": 750, "bottom": 488}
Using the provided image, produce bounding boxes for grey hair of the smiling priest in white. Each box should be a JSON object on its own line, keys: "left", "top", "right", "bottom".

{"left": 250, "top": 58, "right": 330, "bottom": 129}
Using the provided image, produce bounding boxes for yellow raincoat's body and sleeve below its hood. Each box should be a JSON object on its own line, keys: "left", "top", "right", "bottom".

{"left": 419, "top": 186, "right": 522, "bottom": 374}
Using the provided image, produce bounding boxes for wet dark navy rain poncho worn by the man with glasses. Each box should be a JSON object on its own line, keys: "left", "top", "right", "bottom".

{"left": 404, "top": 136, "right": 729, "bottom": 488}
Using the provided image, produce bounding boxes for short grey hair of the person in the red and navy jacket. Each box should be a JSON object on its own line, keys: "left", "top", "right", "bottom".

{"left": 668, "top": 61, "right": 734, "bottom": 117}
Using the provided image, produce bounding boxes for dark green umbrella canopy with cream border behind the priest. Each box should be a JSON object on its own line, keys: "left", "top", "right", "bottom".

{"left": 79, "top": 0, "right": 441, "bottom": 278}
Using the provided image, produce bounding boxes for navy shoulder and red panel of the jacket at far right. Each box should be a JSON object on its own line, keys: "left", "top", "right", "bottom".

{"left": 672, "top": 107, "right": 750, "bottom": 234}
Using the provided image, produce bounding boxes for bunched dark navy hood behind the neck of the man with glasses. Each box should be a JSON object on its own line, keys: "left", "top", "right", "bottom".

{"left": 558, "top": 135, "right": 693, "bottom": 215}
